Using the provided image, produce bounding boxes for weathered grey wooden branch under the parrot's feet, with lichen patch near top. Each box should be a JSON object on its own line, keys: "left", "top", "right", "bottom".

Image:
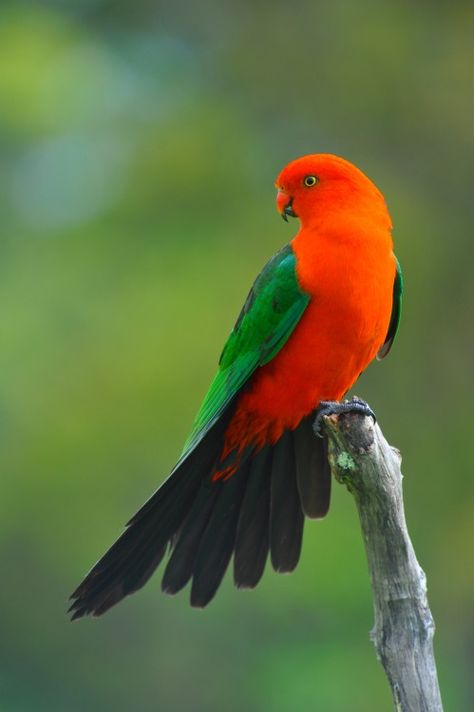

{"left": 324, "top": 414, "right": 443, "bottom": 712}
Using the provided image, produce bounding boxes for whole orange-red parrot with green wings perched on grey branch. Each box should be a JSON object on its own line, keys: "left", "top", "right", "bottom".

{"left": 69, "top": 153, "right": 403, "bottom": 620}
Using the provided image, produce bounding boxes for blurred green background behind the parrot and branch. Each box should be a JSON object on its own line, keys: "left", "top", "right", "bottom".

{"left": 0, "top": 0, "right": 474, "bottom": 712}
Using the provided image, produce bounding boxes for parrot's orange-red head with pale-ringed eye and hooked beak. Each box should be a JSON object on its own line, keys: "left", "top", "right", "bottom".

{"left": 275, "top": 153, "right": 391, "bottom": 228}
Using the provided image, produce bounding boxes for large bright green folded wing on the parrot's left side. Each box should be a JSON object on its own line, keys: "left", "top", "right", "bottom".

{"left": 182, "top": 245, "right": 310, "bottom": 457}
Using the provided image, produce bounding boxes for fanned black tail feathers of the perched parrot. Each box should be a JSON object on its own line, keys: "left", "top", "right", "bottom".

{"left": 70, "top": 409, "right": 331, "bottom": 620}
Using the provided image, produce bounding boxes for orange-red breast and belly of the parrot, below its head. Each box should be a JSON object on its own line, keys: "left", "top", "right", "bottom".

{"left": 225, "top": 224, "right": 396, "bottom": 451}
